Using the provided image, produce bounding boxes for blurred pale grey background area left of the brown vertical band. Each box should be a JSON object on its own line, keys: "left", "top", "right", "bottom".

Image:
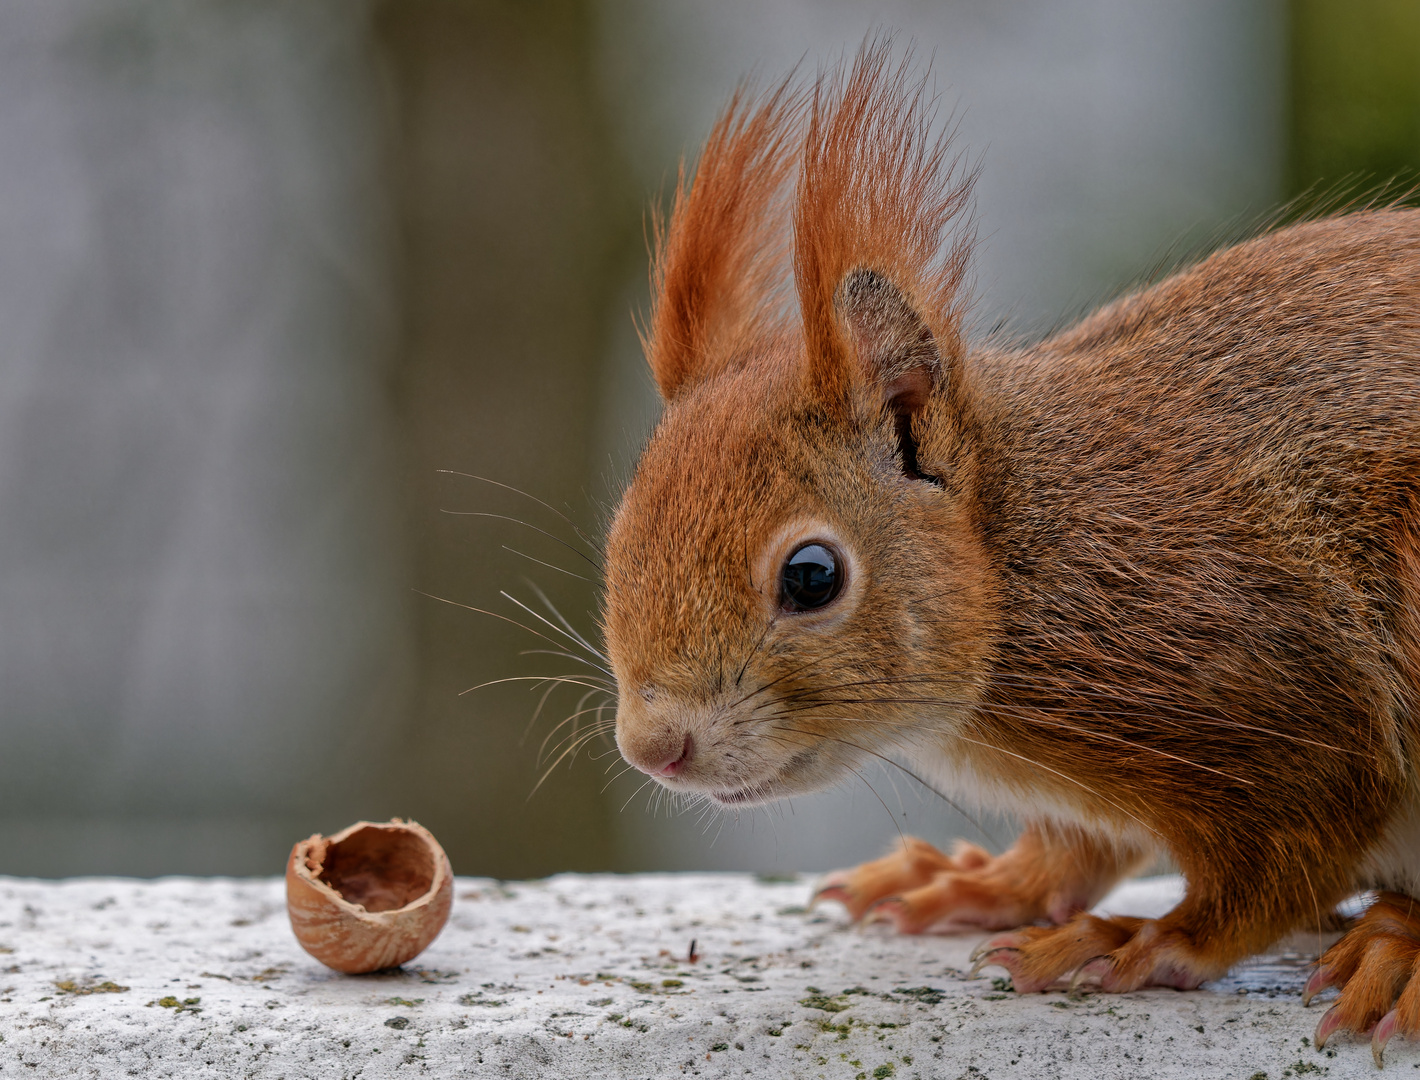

{"left": 0, "top": 0, "right": 412, "bottom": 874}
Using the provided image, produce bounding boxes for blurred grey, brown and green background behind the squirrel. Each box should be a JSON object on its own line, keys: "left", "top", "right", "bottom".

{"left": 0, "top": 0, "right": 1420, "bottom": 877}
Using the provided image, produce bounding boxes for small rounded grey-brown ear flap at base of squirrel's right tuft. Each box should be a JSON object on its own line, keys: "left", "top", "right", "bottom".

{"left": 834, "top": 270, "right": 943, "bottom": 417}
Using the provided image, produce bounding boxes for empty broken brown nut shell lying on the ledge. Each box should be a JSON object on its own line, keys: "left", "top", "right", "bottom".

{"left": 285, "top": 817, "right": 453, "bottom": 975}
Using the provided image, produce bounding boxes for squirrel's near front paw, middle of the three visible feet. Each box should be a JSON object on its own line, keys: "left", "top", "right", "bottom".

{"left": 971, "top": 915, "right": 1225, "bottom": 993}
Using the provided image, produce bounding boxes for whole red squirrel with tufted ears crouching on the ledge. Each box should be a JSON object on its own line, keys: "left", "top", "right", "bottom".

{"left": 602, "top": 45, "right": 1420, "bottom": 1060}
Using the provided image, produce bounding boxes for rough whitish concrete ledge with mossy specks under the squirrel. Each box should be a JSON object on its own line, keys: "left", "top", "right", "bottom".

{"left": 0, "top": 874, "right": 1391, "bottom": 1080}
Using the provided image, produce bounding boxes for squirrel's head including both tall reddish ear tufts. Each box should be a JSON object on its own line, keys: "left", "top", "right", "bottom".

{"left": 604, "top": 45, "right": 991, "bottom": 805}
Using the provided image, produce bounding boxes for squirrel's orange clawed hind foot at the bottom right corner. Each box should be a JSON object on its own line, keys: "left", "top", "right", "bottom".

{"left": 1302, "top": 893, "right": 1420, "bottom": 1066}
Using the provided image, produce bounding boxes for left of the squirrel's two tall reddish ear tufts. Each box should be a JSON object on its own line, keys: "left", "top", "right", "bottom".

{"left": 642, "top": 81, "right": 805, "bottom": 400}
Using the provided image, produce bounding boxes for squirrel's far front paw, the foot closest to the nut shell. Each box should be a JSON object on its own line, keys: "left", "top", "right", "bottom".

{"left": 814, "top": 837, "right": 1085, "bottom": 934}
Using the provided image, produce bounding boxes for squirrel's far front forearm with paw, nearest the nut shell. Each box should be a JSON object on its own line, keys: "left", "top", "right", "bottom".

{"left": 814, "top": 825, "right": 1145, "bottom": 934}
